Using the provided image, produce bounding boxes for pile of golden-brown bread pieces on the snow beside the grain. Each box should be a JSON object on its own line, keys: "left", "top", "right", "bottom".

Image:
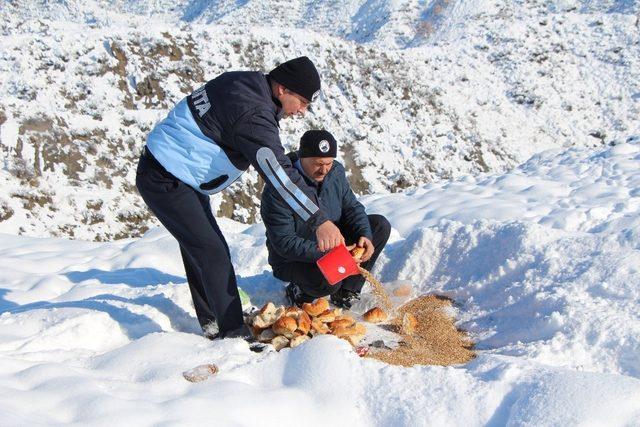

{"left": 248, "top": 298, "right": 387, "bottom": 351}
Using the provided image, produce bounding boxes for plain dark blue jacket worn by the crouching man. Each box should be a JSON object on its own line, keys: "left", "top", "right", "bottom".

{"left": 260, "top": 153, "right": 373, "bottom": 276}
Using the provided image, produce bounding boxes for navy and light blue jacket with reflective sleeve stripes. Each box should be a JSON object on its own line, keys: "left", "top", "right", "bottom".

{"left": 147, "top": 71, "right": 327, "bottom": 230}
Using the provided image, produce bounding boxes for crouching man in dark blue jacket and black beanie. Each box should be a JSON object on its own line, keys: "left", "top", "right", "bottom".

{"left": 260, "top": 130, "right": 391, "bottom": 309}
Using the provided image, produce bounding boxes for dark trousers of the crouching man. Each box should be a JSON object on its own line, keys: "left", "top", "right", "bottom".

{"left": 273, "top": 215, "right": 391, "bottom": 298}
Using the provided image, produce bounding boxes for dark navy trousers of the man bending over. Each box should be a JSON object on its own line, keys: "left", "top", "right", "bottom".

{"left": 136, "top": 148, "right": 243, "bottom": 336}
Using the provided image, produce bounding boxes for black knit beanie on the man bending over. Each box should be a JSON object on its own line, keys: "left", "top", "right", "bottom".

{"left": 269, "top": 56, "right": 320, "bottom": 102}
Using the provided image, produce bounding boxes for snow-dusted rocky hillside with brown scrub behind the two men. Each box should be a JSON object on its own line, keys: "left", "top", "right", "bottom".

{"left": 0, "top": 0, "right": 640, "bottom": 240}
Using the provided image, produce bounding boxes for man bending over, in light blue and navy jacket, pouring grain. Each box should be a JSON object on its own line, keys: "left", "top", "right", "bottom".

{"left": 136, "top": 56, "right": 344, "bottom": 339}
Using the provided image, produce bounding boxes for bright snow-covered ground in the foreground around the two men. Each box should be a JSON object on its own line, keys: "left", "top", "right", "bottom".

{"left": 0, "top": 138, "right": 640, "bottom": 426}
